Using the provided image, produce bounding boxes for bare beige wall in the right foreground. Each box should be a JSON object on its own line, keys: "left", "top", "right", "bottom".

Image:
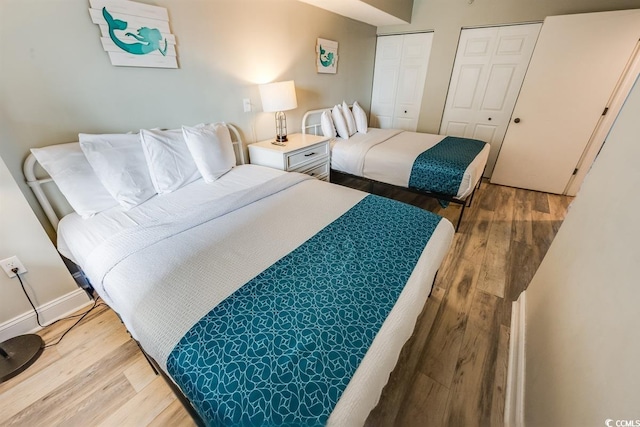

{"left": 525, "top": 82, "right": 640, "bottom": 426}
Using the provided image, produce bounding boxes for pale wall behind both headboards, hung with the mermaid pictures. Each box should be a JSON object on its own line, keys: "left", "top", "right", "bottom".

{"left": 0, "top": 0, "right": 376, "bottom": 324}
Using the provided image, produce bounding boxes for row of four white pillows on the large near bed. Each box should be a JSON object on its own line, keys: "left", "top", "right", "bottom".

{"left": 31, "top": 123, "right": 236, "bottom": 218}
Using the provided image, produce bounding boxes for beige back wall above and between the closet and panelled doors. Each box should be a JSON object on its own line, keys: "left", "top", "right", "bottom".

{"left": 378, "top": 0, "right": 640, "bottom": 133}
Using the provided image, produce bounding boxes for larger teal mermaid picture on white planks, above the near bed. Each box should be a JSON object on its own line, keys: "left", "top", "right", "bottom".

{"left": 89, "top": 0, "right": 178, "bottom": 68}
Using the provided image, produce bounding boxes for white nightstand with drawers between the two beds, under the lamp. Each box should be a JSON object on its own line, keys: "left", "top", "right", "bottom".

{"left": 249, "top": 133, "right": 330, "bottom": 181}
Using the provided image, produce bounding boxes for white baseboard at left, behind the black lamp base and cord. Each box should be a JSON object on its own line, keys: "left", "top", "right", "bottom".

{"left": 0, "top": 289, "right": 92, "bottom": 342}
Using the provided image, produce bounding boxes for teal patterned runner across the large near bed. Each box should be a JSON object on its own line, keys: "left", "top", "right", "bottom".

{"left": 167, "top": 195, "right": 441, "bottom": 426}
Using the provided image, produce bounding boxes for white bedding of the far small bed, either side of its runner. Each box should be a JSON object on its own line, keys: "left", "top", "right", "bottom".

{"left": 331, "top": 128, "right": 490, "bottom": 199}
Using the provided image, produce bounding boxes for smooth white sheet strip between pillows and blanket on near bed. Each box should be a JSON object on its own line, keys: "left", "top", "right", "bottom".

{"left": 57, "top": 165, "right": 285, "bottom": 267}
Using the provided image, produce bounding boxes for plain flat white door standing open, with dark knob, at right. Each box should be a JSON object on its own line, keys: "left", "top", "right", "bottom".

{"left": 491, "top": 10, "right": 640, "bottom": 194}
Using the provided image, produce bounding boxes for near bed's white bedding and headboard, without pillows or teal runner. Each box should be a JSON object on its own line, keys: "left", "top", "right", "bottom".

{"left": 25, "top": 122, "right": 454, "bottom": 426}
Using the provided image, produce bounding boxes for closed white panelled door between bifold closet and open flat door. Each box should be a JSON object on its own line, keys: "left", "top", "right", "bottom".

{"left": 440, "top": 23, "right": 542, "bottom": 176}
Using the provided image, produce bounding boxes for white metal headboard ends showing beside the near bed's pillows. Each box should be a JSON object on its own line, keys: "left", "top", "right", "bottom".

{"left": 22, "top": 123, "right": 246, "bottom": 230}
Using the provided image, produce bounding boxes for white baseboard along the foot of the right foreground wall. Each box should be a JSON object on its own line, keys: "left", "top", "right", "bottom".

{"left": 504, "top": 291, "right": 527, "bottom": 427}
